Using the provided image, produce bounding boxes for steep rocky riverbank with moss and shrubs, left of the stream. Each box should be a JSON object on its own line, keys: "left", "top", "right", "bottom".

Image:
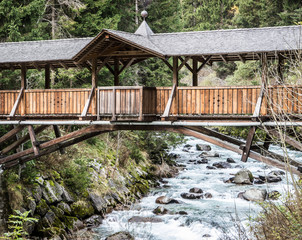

{"left": 3, "top": 132, "right": 184, "bottom": 239}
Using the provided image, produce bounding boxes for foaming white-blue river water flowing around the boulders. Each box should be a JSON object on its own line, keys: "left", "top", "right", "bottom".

{"left": 95, "top": 137, "right": 302, "bottom": 240}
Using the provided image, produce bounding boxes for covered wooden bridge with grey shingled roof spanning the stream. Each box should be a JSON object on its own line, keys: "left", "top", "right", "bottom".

{"left": 0, "top": 21, "right": 302, "bottom": 174}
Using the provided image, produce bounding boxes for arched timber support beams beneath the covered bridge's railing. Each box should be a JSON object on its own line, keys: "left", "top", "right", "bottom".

{"left": 0, "top": 121, "right": 302, "bottom": 175}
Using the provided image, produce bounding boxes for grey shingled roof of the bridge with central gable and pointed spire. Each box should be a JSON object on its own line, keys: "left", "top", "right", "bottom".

{"left": 0, "top": 21, "right": 302, "bottom": 69}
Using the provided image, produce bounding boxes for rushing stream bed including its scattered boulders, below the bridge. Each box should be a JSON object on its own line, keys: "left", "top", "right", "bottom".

{"left": 94, "top": 138, "right": 302, "bottom": 240}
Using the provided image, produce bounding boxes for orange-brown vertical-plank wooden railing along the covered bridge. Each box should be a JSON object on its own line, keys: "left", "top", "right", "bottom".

{"left": 0, "top": 85, "right": 302, "bottom": 121}
